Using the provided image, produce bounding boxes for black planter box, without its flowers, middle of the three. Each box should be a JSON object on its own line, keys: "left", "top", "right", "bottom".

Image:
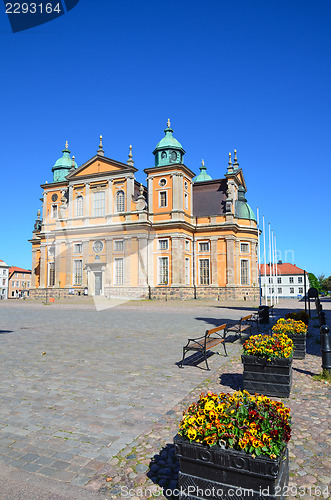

{"left": 241, "top": 354, "right": 292, "bottom": 398}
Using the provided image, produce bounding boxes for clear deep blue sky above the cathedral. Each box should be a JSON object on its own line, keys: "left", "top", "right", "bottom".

{"left": 0, "top": 0, "right": 331, "bottom": 276}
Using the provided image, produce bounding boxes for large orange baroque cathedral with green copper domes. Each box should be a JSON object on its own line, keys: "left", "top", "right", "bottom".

{"left": 30, "top": 120, "right": 259, "bottom": 300}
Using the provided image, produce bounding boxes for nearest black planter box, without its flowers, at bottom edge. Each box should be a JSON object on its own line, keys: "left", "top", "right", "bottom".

{"left": 174, "top": 436, "right": 289, "bottom": 500}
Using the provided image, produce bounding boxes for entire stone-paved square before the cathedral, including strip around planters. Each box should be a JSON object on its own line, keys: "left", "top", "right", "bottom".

{"left": 0, "top": 300, "right": 331, "bottom": 500}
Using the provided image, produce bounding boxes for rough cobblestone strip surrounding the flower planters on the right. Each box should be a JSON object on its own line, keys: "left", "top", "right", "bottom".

{"left": 85, "top": 301, "right": 331, "bottom": 500}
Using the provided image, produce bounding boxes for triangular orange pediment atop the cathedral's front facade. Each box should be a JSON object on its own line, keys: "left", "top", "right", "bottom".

{"left": 66, "top": 155, "right": 137, "bottom": 181}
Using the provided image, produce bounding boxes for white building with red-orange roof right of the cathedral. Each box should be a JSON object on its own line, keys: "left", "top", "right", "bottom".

{"left": 260, "top": 261, "right": 309, "bottom": 298}
